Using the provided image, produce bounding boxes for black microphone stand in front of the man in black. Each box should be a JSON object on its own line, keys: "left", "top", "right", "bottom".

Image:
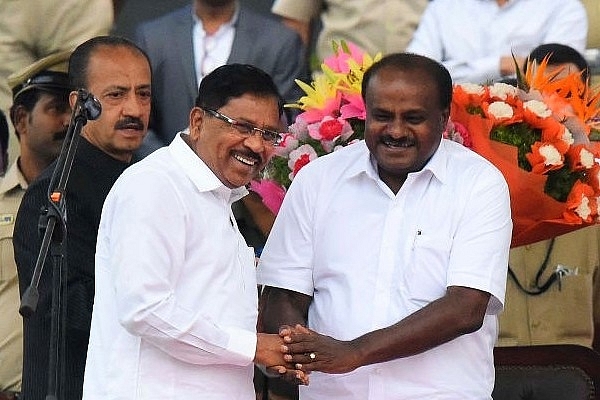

{"left": 19, "top": 89, "right": 102, "bottom": 400}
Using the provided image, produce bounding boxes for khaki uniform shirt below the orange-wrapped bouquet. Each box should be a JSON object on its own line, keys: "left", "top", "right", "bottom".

{"left": 498, "top": 226, "right": 600, "bottom": 347}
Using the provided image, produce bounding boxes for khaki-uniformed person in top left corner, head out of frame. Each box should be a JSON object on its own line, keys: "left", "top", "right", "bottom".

{"left": 0, "top": 0, "right": 115, "bottom": 169}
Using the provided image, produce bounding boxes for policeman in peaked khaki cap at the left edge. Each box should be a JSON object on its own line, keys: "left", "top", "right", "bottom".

{"left": 0, "top": 51, "right": 71, "bottom": 400}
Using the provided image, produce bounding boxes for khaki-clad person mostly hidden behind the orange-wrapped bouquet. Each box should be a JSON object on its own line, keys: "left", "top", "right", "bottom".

{"left": 498, "top": 43, "right": 600, "bottom": 350}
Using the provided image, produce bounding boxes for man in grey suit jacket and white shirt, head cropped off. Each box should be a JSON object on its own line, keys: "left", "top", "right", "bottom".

{"left": 136, "top": 0, "right": 307, "bottom": 153}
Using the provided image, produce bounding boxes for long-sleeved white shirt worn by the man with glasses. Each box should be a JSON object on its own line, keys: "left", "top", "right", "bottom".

{"left": 83, "top": 135, "right": 258, "bottom": 400}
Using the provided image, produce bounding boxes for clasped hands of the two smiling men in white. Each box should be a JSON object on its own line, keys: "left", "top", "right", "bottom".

{"left": 263, "top": 325, "right": 359, "bottom": 385}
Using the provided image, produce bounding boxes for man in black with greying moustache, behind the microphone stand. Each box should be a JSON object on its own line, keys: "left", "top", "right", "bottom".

{"left": 14, "top": 36, "right": 151, "bottom": 400}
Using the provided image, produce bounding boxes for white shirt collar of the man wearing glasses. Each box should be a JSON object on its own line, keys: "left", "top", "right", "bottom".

{"left": 169, "top": 129, "right": 248, "bottom": 203}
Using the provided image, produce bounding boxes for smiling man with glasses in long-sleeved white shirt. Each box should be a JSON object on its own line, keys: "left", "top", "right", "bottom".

{"left": 83, "top": 64, "right": 304, "bottom": 400}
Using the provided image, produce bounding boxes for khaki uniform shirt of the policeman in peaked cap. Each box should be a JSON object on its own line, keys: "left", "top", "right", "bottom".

{"left": 0, "top": 162, "right": 27, "bottom": 392}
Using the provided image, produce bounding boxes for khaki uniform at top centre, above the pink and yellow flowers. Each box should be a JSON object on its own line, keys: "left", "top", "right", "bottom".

{"left": 271, "top": 0, "right": 428, "bottom": 60}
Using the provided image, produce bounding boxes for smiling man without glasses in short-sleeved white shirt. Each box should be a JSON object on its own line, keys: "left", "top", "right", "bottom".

{"left": 258, "top": 53, "right": 512, "bottom": 400}
